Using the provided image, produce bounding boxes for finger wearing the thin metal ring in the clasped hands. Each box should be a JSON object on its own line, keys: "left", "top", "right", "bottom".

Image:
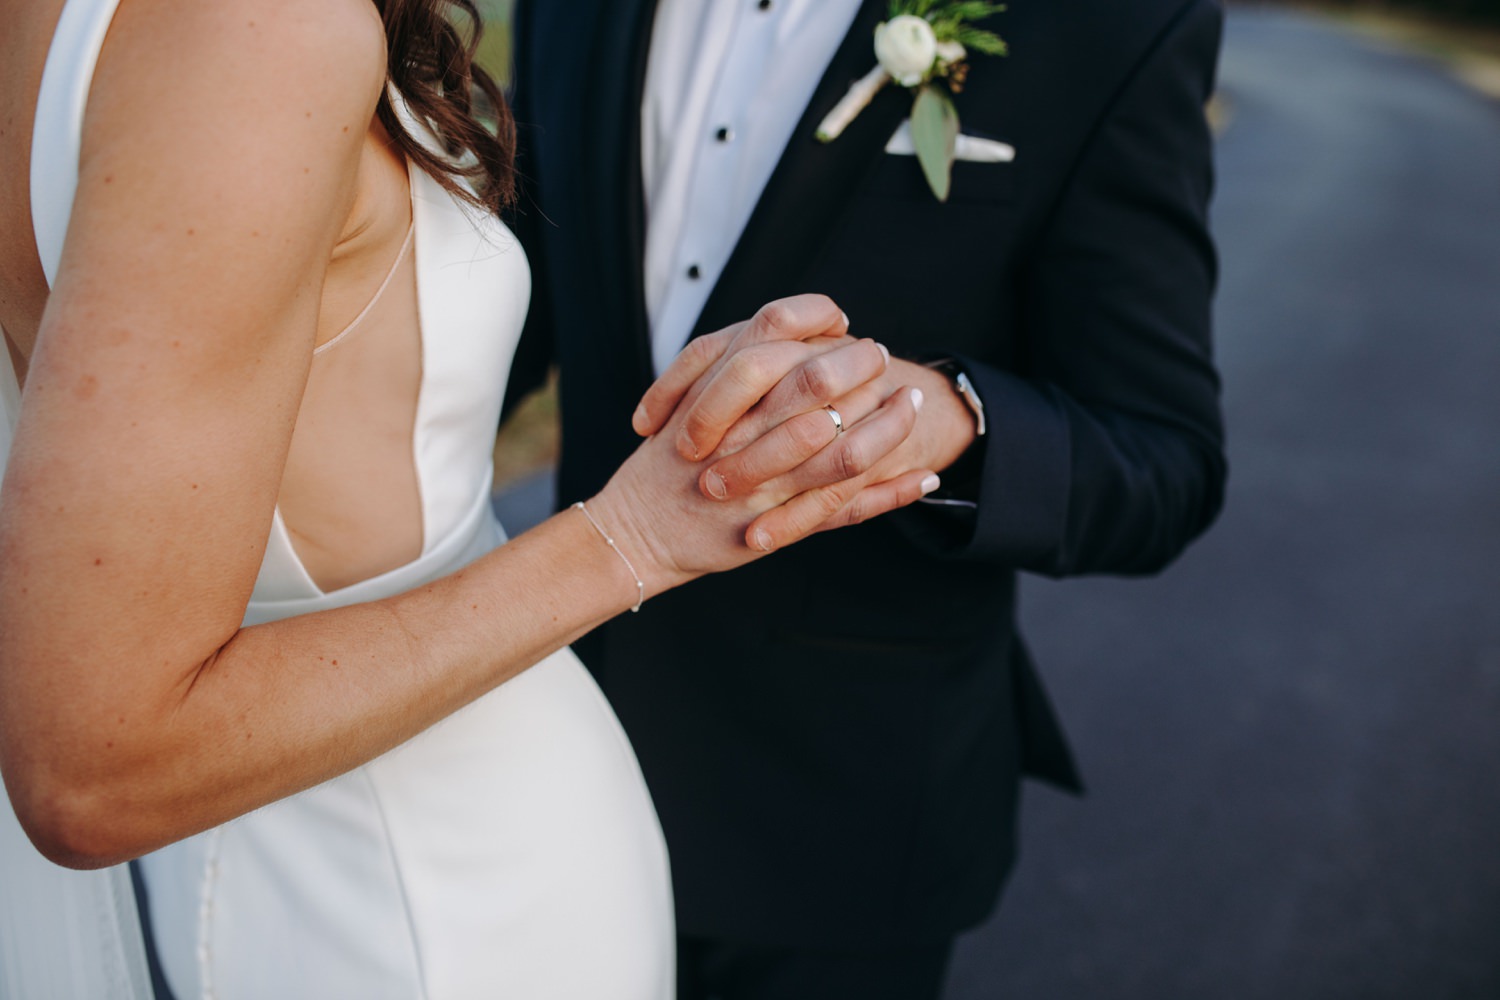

{"left": 698, "top": 382, "right": 885, "bottom": 499}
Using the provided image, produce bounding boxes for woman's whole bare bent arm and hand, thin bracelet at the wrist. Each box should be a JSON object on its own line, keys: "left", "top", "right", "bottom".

{"left": 0, "top": 0, "right": 920, "bottom": 867}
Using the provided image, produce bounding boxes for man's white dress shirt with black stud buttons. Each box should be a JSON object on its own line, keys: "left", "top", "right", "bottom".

{"left": 641, "top": 0, "right": 875, "bottom": 372}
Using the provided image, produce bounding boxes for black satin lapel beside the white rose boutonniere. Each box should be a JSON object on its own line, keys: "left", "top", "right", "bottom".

{"left": 693, "top": 0, "right": 912, "bottom": 336}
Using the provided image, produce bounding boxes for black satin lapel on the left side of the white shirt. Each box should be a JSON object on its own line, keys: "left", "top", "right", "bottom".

{"left": 582, "top": 0, "right": 656, "bottom": 388}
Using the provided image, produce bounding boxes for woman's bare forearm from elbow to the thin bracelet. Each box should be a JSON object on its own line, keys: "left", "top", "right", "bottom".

{"left": 3, "top": 511, "right": 651, "bottom": 868}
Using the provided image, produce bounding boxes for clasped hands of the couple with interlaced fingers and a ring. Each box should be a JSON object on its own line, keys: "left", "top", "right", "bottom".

{"left": 590, "top": 295, "right": 974, "bottom": 597}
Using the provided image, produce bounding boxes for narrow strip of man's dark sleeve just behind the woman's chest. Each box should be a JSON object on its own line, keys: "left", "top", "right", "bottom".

{"left": 501, "top": 0, "right": 555, "bottom": 421}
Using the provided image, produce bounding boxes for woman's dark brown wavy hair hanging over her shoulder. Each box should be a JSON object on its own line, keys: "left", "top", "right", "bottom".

{"left": 375, "top": 0, "right": 516, "bottom": 211}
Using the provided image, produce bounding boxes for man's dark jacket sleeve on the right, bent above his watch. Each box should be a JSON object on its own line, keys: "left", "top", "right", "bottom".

{"left": 950, "top": 0, "right": 1227, "bottom": 576}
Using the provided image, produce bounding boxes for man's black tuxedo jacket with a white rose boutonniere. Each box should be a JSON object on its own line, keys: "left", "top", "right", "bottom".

{"left": 512, "top": 0, "right": 1226, "bottom": 945}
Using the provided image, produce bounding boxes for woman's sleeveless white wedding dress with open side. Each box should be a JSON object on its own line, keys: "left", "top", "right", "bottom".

{"left": 0, "top": 0, "right": 672, "bottom": 1000}
